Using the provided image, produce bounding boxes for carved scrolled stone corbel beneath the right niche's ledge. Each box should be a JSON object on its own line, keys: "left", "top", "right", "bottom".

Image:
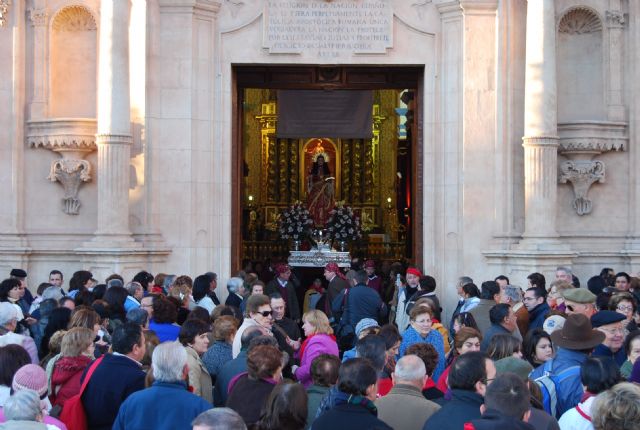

{"left": 559, "top": 160, "right": 604, "bottom": 215}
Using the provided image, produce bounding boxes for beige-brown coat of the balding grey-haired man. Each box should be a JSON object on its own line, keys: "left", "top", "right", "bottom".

{"left": 375, "top": 384, "right": 440, "bottom": 430}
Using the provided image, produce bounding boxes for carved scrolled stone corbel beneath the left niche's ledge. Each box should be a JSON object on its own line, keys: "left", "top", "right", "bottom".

{"left": 47, "top": 158, "right": 91, "bottom": 215}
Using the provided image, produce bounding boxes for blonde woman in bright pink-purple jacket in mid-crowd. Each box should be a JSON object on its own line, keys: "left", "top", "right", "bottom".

{"left": 291, "top": 309, "right": 339, "bottom": 388}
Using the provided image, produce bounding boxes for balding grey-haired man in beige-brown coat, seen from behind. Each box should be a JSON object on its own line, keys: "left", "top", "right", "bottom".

{"left": 376, "top": 355, "right": 440, "bottom": 430}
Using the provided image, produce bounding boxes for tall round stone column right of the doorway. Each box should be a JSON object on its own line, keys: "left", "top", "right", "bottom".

{"left": 522, "top": 0, "right": 558, "bottom": 242}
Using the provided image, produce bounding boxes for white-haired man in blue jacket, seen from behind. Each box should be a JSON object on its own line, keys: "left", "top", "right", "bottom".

{"left": 113, "top": 342, "right": 212, "bottom": 430}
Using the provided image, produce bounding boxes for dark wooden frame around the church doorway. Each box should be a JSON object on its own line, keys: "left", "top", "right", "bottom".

{"left": 230, "top": 65, "right": 424, "bottom": 273}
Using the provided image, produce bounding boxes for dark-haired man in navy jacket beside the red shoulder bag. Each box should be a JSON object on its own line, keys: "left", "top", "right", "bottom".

{"left": 82, "top": 322, "right": 146, "bottom": 430}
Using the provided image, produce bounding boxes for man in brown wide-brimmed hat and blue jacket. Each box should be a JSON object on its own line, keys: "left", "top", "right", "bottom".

{"left": 531, "top": 314, "right": 605, "bottom": 417}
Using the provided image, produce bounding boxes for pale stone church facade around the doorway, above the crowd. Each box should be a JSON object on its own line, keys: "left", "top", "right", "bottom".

{"left": 0, "top": 0, "right": 640, "bottom": 310}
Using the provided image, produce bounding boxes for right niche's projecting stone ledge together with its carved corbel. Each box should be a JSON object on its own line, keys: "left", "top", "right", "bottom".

{"left": 558, "top": 121, "right": 629, "bottom": 216}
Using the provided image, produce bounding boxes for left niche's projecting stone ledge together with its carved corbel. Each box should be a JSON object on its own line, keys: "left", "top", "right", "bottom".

{"left": 27, "top": 118, "right": 97, "bottom": 215}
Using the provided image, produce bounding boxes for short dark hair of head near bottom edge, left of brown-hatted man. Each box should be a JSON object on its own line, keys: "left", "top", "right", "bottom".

{"left": 484, "top": 372, "right": 531, "bottom": 420}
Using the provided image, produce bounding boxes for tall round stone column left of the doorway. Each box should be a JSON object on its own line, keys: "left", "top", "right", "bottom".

{"left": 94, "top": 0, "right": 132, "bottom": 244}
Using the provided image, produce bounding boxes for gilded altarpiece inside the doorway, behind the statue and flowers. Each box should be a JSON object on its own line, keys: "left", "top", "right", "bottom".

{"left": 242, "top": 89, "right": 398, "bottom": 258}
